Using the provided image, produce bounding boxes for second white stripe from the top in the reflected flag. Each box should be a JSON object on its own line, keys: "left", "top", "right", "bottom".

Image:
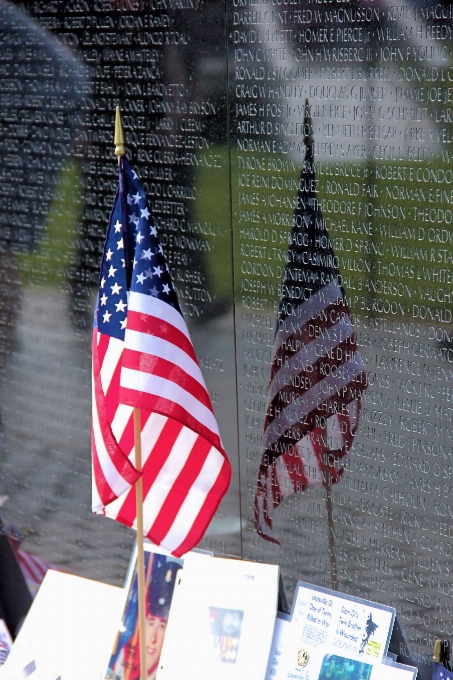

{"left": 269, "top": 317, "right": 354, "bottom": 401}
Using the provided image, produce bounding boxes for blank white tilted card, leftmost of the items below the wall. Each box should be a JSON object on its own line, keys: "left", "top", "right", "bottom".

{"left": 1, "top": 570, "right": 126, "bottom": 680}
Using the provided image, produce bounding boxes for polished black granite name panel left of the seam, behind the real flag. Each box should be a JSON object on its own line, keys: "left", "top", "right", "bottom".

{"left": 0, "top": 0, "right": 241, "bottom": 583}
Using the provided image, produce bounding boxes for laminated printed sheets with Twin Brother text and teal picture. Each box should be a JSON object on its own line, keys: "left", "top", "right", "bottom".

{"left": 266, "top": 582, "right": 395, "bottom": 680}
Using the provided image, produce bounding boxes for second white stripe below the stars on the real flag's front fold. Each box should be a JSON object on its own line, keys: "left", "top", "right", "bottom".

{"left": 124, "top": 330, "right": 206, "bottom": 389}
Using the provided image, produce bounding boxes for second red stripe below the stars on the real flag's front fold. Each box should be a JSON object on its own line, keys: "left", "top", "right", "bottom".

{"left": 123, "top": 349, "right": 212, "bottom": 411}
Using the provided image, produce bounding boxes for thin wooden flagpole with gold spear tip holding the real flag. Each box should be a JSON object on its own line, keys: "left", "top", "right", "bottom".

{"left": 113, "top": 106, "right": 147, "bottom": 680}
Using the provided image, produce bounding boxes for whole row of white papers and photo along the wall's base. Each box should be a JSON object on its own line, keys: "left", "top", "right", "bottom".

{"left": 0, "top": 543, "right": 417, "bottom": 680}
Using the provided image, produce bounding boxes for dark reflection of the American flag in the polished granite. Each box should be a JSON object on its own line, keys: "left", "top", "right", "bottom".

{"left": 255, "top": 102, "right": 366, "bottom": 542}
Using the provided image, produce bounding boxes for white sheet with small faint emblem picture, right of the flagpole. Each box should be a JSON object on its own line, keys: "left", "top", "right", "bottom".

{"left": 158, "top": 553, "right": 279, "bottom": 680}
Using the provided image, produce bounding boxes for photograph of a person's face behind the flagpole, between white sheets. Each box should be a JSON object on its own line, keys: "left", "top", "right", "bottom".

{"left": 105, "top": 552, "right": 183, "bottom": 680}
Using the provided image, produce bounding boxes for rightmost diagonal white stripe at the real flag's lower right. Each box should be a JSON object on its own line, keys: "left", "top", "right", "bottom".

{"left": 162, "top": 446, "right": 225, "bottom": 551}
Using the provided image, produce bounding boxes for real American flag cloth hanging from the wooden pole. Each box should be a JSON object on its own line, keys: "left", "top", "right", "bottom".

{"left": 92, "top": 156, "right": 231, "bottom": 556}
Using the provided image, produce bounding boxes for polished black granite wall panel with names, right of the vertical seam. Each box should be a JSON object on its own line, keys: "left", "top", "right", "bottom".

{"left": 229, "top": 0, "right": 453, "bottom": 672}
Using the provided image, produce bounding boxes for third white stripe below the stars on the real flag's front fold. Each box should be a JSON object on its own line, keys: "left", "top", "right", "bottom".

{"left": 121, "top": 367, "right": 219, "bottom": 435}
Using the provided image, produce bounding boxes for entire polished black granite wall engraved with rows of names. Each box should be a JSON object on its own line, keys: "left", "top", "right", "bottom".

{"left": 0, "top": 0, "right": 453, "bottom": 674}
